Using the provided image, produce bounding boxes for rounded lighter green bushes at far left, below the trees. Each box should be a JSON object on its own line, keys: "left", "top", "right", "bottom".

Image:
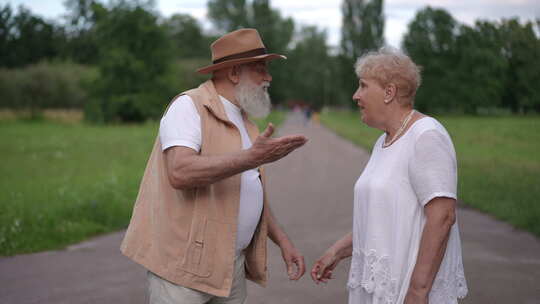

{"left": 0, "top": 62, "right": 97, "bottom": 118}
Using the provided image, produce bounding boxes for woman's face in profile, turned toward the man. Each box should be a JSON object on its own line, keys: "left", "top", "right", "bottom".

{"left": 353, "top": 78, "right": 385, "bottom": 128}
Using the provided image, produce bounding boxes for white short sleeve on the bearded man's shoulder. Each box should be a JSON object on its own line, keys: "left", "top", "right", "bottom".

{"left": 159, "top": 95, "right": 202, "bottom": 152}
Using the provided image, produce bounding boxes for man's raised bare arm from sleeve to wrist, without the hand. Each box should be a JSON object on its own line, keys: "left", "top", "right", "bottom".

{"left": 165, "top": 149, "right": 259, "bottom": 189}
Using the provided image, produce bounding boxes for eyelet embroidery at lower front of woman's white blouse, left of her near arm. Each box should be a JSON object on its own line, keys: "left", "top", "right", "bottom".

{"left": 347, "top": 249, "right": 397, "bottom": 304}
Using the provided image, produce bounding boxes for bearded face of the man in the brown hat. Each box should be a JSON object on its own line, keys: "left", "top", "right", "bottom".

{"left": 235, "top": 62, "right": 272, "bottom": 117}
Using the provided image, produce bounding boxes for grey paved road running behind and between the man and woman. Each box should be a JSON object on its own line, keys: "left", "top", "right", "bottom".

{"left": 0, "top": 116, "right": 540, "bottom": 304}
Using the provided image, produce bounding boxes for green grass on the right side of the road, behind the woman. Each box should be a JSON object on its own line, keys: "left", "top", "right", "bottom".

{"left": 321, "top": 111, "right": 540, "bottom": 236}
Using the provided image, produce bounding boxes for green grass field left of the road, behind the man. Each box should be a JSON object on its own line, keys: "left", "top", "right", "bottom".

{"left": 0, "top": 112, "right": 285, "bottom": 255}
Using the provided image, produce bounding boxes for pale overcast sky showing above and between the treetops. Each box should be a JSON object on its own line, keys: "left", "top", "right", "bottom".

{"left": 4, "top": 0, "right": 540, "bottom": 47}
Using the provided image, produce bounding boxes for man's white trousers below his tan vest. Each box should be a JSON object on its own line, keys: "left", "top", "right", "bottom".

{"left": 147, "top": 254, "right": 247, "bottom": 304}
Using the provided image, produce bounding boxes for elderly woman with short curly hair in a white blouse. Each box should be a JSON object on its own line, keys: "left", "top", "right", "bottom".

{"left": 311, "top": 48, "right": 467, "bottom": 304}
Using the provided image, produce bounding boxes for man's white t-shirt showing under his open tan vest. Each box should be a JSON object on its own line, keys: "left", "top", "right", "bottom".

{"left": 159, "top": 95, "right": 263, "bottom": 255}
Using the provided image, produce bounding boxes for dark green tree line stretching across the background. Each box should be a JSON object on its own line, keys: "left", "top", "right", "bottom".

{"left": 0, "top": 0, "right": 540, "bottom": 122}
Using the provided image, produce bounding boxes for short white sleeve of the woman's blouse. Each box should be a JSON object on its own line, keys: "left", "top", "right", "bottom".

{"left": 409, "top": 129, "right": 457, "bottom": 206}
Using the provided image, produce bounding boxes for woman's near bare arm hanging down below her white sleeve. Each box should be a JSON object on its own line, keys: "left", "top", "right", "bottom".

{"left": 404, "top": 197, "right": 456, "bottom": 304}
